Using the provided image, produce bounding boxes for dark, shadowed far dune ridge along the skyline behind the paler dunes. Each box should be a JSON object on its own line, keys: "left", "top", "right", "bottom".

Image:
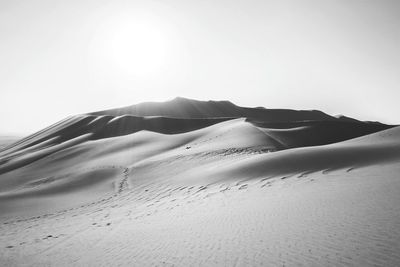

{"left": 0, "top": 98, "right": 393, "bottom": 176}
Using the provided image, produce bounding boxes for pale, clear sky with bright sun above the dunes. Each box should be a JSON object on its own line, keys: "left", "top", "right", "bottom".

{"left": 0, "top": 0, "right": 400, "bottom": 135}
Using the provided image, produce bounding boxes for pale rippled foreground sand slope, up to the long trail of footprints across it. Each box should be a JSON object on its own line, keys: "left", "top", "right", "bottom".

{"left": 0, "top": 165, "right": 400, "bottom": 266}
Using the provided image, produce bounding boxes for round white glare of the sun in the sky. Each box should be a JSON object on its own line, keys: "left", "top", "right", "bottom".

{"left": 95, "top": 11, "right": 173, "bottom": 78}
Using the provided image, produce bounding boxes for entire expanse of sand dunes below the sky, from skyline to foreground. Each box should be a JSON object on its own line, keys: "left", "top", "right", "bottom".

{"left": 0, "top": 98, "right": 400, "bottom": 266}
